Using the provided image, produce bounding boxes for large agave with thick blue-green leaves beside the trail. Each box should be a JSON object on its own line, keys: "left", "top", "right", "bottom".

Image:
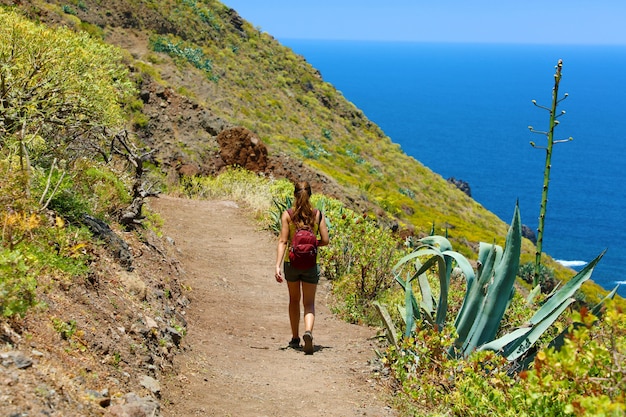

{"left": 377, "top": 205, "right": 604, "bottom": 361}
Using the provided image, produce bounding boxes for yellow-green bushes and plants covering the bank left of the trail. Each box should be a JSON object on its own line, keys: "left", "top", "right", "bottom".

{"left": 0, "top": 10, "right": 134, "bottom": 317}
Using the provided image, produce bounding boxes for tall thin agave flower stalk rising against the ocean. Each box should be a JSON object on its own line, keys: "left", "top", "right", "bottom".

{"left": 528, "top": 59, "right": 573, "bottom": 287}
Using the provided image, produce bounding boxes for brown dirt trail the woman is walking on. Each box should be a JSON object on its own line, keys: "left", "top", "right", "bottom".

{"left": 150, "top": 197, "right": 395, "bottom": 417}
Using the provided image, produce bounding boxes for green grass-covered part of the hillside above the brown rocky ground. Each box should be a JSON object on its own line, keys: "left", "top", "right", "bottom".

{"left": 11, "top": 0, "right": 608, "bottom": 300}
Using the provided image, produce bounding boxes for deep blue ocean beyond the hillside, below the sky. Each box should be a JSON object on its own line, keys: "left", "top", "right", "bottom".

{"left": 281, "top": 40, "right": 626, "bottom": 296}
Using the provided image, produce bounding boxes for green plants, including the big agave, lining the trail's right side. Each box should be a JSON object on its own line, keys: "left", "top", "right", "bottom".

{"left": 178, "top": 169, "right": 626, "bottom": 416}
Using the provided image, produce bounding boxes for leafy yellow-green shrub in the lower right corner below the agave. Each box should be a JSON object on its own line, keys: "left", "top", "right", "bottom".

{"left": 450, "top": 301, "right": 626, "bottom": 417}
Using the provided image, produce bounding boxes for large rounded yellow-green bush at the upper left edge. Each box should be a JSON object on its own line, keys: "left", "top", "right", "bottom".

{"left": 0, "top": 10, "right": 134, "bottom": 193}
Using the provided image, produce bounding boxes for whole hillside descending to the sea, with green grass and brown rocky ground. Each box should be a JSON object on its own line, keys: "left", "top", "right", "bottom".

{"left": 0, "top": 0, "right": 604, "bottom": 324}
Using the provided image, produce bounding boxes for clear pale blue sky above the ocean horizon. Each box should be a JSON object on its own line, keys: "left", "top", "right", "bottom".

{"left": 222, "top": 0, "right": 626, "bottom": 45}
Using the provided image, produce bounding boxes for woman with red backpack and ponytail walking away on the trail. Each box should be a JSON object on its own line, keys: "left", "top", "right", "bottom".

{"left": 275, "top": 181, "right": 329, "bottom": 355}
